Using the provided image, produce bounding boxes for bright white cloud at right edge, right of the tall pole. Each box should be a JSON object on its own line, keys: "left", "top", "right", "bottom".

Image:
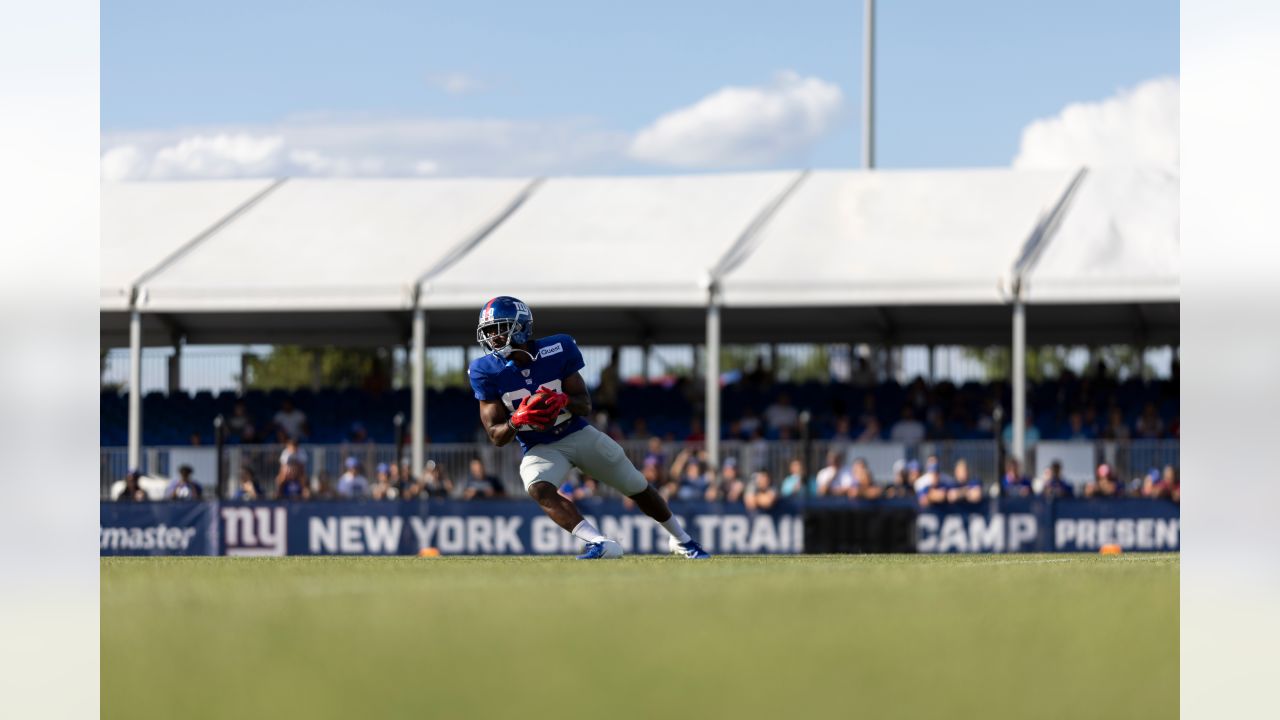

{"left": 1014, "top": 78, "right": 1179, "bottom": 172}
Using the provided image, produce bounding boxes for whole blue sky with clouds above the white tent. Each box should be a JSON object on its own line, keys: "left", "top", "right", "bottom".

{"left": 101, "top": 0, "right": 1179, "bottom": 179}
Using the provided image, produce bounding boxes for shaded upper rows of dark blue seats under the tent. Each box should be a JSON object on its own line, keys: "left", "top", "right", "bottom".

{"left": 101, "top": 363, "right": 1180, "bottom": 446}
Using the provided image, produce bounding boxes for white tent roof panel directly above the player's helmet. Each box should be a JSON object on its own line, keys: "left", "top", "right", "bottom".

{"left": 422, "top": 172, "right": 799, "bottom": 310}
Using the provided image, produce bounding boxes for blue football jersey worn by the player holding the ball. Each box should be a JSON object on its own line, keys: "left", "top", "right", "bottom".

{"left": 467, "top": 334, "right": 586, "bottom": 452}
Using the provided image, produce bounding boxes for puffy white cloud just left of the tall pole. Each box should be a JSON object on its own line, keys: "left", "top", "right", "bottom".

{"left": 628, "top": 72, "right": 844, "bottom": 168}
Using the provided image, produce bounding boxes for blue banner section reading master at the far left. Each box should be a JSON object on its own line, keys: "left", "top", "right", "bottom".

{"left": 99, "top": 502, "right": 218, "bottom": 555}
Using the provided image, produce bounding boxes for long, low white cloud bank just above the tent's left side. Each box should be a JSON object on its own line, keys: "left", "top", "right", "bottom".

{"left": 101, "top": 115, "right": 627, "bottom": 181}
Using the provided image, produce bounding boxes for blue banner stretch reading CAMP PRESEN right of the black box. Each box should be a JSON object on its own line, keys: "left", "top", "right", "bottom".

{"left": 915, "top": 498, "right": 1180, "bottom": 552}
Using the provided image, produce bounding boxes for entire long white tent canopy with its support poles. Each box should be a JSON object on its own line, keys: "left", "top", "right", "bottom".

{"left": 101, "top": 169, "right": 1179, "bottom": 474}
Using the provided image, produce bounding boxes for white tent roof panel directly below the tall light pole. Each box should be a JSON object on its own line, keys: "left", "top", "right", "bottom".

{"left": 722, "top": 170, "right": 1073, "bottom": 307}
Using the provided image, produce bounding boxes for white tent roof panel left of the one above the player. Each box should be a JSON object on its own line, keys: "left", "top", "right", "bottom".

{"left": 143, "top": 179, "right": 540, "bottom": 313}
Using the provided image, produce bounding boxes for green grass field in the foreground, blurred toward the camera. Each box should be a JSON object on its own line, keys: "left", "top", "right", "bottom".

{"left": 101, "top": 555, "right": 1179, "bottom": 720}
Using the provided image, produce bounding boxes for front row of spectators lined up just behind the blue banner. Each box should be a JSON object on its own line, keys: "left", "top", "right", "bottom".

{"left": 116, "top": 438, "right": 1180, "bottom": 510}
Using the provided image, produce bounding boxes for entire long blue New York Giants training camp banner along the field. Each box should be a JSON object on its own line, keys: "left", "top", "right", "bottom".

{"left": 100, "top": 498, "right": 1180, "bottom": 556}
